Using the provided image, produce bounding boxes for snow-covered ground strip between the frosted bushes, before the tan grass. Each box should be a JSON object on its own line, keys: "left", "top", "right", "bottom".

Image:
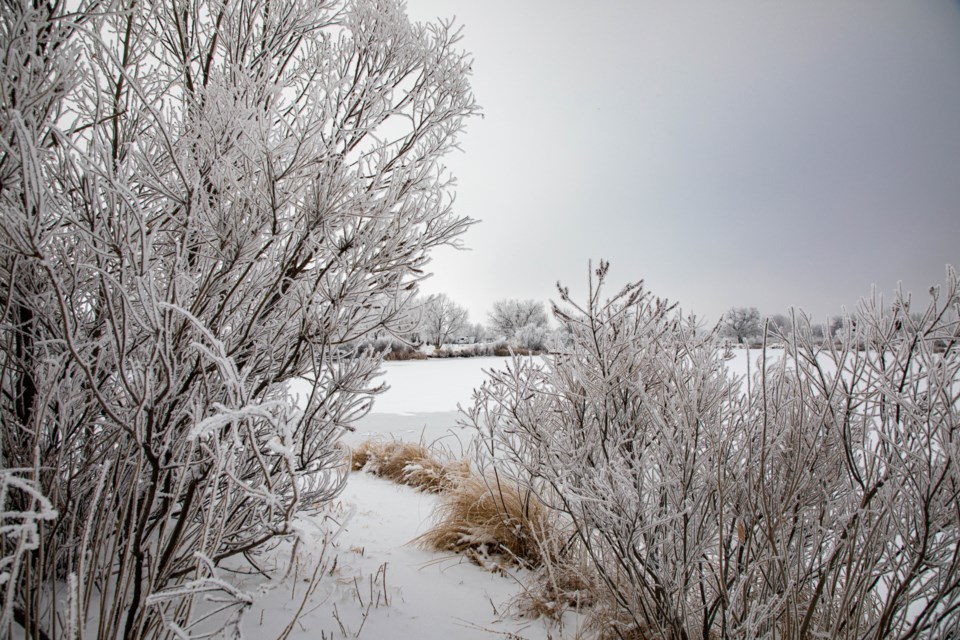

{"left": 244, "top": 472, "right": 557, "bottom": 640}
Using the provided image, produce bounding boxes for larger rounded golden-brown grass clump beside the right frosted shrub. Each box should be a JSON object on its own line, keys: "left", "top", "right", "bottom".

{"left": 417, "top": 475, "right": 556, "bottom": 567}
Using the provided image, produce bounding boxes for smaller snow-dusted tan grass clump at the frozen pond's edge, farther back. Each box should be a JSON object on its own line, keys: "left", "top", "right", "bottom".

{"left": 352, "top": 440, "right": 470, "bottom": 493}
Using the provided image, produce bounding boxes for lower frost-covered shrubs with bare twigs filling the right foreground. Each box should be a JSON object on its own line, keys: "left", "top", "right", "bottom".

{"left": 468, "top": 264, "right": 960, "bottom": 640}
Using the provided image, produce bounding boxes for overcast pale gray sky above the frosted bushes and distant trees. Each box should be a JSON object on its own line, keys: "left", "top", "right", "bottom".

{"left": 407, "top": 0, "right": 960, "bottom": 321}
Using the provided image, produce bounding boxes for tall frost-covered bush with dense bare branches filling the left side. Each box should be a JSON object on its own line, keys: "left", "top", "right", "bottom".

{"left": 0, "top": 0, "right": 477, "bottom": 638}
